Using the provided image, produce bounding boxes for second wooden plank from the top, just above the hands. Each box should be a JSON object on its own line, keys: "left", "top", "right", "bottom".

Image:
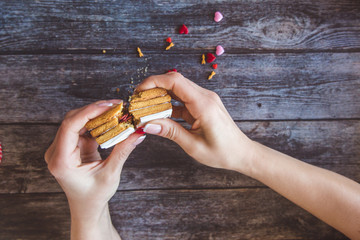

{"left": 0, "top": 53, "right": 360, "bottom": 123}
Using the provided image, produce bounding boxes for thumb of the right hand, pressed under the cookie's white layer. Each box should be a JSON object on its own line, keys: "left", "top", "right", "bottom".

{"left": 144, "top": 118, "right": 196, "bottom": 152}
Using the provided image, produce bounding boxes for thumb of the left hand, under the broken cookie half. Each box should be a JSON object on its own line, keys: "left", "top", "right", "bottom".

{"left": 106, "top": 133, "right": 145, "bottom": 172}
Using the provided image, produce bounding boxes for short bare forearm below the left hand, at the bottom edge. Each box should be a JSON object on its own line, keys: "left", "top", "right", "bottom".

{"left": 70, "top": 204, "right": 120, "bottom": 240}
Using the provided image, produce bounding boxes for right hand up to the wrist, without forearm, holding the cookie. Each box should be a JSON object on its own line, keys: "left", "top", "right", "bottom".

{"left": 136, "top": 72, "right": 254, "bottom": 174}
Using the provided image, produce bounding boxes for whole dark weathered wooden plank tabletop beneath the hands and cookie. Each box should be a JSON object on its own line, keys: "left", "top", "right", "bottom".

{"left": 0, "top": 0, "right": 360, "bottom": 240}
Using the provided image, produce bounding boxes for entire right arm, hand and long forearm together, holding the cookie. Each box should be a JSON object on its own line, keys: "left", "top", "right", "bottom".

{"left": 137, "top": 73, "right": 360, "bottom": 239}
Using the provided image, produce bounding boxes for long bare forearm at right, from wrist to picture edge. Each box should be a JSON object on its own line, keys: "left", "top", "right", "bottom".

{"left": 245, "top": 143, "right": 360, "bottom": 239}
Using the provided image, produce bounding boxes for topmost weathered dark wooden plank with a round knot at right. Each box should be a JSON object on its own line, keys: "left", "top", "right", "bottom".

{"left": 0, "top": 0, "right": 360, "bottom": 53}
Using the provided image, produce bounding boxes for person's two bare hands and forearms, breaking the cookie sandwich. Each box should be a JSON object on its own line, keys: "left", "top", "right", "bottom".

{"left": 45, "top": 73, "right": 360, "bottom": 239}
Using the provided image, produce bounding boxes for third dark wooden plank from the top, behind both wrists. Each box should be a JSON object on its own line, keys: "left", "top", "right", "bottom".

{"left": 0, "top": 121, "right": 360, "bottom": 193}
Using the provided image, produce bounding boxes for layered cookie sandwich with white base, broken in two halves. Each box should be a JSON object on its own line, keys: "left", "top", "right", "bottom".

{"left": 85, "top": 88, "right": 172, "bottom": 149}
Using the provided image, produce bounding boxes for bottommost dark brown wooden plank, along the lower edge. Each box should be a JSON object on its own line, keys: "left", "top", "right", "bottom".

{"left": 0, "top": 189, "right": 347, "bottom": 240}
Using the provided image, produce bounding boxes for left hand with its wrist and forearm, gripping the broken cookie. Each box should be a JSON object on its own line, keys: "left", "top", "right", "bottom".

{"left": 45, "top": 100, "right": 144, "bottom": 239}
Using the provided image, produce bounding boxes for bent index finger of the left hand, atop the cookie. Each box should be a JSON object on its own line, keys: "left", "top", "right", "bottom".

{"left": 56, "top": 100, "right": 121, "bottom": 154}
